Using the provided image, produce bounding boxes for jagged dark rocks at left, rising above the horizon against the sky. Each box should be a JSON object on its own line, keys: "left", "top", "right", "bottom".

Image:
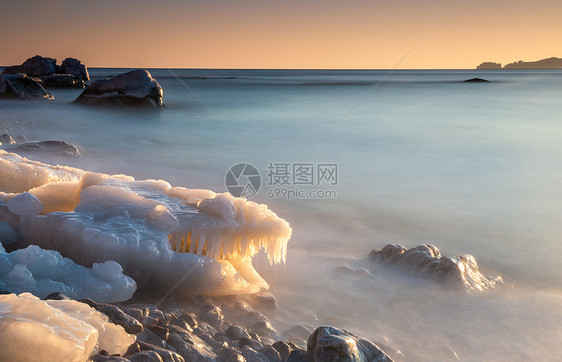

{"left": 2, "top": 55, "right": 90, "bottom": 88}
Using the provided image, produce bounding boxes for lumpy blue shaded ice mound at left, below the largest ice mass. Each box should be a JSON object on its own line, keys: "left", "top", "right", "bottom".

{"left": 0, "top": 245, "right": 136, "bottom": 302}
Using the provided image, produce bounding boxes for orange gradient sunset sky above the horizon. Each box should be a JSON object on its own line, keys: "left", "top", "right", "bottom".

{"left": 0, "top": 0, "right": 562, "bottom": 69}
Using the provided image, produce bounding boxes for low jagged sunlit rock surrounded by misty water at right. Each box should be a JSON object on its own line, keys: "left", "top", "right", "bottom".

{"left": 368, "top": 244, "right": 503, "bottom": 293}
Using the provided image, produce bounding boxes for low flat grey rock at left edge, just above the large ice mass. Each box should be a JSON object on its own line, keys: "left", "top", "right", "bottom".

{"left": 0, "top": 133, "right": 80, "bottom": 157}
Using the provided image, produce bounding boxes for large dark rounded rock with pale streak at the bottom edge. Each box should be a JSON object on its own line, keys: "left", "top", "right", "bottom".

{"left": 307, "top": 326, "right": 392, "bottom": 362}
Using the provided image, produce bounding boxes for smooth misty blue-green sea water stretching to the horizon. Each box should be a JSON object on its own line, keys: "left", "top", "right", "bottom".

{"left": 0, "top": 68, "right": 562, "bottom": 360}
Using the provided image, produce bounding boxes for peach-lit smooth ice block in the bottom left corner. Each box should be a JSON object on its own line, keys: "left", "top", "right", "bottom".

{"left": 0, "top": 293, "right": 136, "bottom": 362}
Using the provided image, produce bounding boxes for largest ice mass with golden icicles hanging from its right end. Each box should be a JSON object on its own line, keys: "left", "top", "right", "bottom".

{"left": 0, "top": 150, "right": 292, "bottom": 295}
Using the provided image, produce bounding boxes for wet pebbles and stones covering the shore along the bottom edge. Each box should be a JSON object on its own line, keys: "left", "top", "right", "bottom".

{"left": 26, "top": 293, "right": 392, "bottom": 362}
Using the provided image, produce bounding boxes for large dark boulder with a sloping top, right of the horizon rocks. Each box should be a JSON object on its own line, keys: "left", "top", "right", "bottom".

{"left": 74, "top": 69, "right": 163, "bottom": 108}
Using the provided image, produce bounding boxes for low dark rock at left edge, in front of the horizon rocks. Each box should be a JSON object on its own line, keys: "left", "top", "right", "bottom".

{"left": 0, "top": 73, "right": 55, "bottom": 101}
